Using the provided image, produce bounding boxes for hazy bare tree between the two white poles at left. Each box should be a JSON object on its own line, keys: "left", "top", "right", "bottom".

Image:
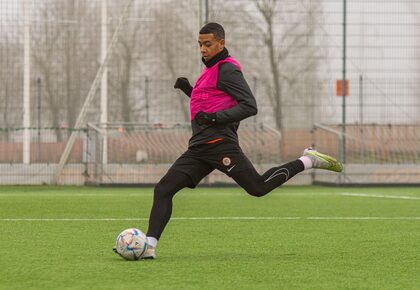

{"left": 32, "top": 0, "right": 99, "bottom": 140}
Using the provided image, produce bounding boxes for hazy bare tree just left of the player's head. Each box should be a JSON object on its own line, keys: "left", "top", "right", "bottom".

{"left": 109, "top": 1, "right": 198, "bottom": 122}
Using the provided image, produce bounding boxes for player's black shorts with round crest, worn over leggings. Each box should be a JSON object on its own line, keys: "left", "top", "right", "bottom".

{"left": 169, "top": 140, "right": 254, "bottom": 187}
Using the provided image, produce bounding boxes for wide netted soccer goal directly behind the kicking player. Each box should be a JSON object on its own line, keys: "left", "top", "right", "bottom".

{"left": 85, "top": 123, "right": 281, "bottom": 184}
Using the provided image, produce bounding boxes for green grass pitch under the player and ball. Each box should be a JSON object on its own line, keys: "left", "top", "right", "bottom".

{"left": 0, "top": 186, "right": 420, "bottom": 289}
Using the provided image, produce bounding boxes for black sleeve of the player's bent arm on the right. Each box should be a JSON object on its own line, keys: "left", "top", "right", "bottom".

{"left": 216, "top": 63, "right": 257, "bottom": 124}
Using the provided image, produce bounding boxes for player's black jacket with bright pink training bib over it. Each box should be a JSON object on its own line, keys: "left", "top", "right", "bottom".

{"left": 187, "top": 48, "right": 257, "bottom": 147}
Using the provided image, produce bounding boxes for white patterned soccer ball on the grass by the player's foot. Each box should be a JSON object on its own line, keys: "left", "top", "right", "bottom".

{"left": 114, "top": 228, "right": 148, "bottom": 260}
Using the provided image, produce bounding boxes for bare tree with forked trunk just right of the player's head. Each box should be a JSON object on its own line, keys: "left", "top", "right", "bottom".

{"left": 211, "top": 0, "right": 322, "bottom": 159}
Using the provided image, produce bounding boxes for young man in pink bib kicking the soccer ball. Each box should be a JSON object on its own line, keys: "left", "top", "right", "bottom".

{"left": 140, "top": 23, "right": 343, "bottom": 259}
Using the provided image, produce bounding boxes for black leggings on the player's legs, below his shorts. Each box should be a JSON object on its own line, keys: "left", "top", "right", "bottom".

{"left": 147, "top": 160, "right": 304, "bottom": 240}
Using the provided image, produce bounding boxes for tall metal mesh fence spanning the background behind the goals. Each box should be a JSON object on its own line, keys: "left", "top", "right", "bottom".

{"left": 0, "top": 0, "right": 420, "bottom": 184}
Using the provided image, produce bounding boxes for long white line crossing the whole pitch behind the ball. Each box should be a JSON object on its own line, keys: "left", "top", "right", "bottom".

{"left": 0, "top": 216, "right": 420, "bottom": 222}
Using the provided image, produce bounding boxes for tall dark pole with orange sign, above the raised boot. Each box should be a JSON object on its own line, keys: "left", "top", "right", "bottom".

{"left": 340, "top": 0, "right": 347, "bottom": 163}
